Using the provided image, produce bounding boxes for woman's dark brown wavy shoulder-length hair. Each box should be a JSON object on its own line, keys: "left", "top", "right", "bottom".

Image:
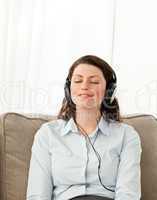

{"left": 57, "top": 55, "right": 122, "bottom": 122}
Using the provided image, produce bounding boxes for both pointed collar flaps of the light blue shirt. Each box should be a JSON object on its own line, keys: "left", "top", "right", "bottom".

{"left": 61, "top": 116, "right": 110, "bottom": 136}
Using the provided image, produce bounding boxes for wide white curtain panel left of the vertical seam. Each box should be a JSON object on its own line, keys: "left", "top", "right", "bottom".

{"left": 0, "top": 0, "right": 115, "bottom": 114}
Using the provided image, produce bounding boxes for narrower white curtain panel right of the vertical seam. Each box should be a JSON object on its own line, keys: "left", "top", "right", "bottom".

{"left": 113, "top": 0, "right": 157, "bottom": 116}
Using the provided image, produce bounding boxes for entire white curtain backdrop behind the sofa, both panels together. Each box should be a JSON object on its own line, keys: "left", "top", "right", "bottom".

{"left": 0, "top": 0, "right": 157, "bottom": 114}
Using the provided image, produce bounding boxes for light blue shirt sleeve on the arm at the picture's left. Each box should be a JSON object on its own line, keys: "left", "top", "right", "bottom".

{"left": 26, "top": 124, "right": 53, "bottom": 200}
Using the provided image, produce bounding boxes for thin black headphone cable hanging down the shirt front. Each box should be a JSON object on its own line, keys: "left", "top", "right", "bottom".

{"left": 75, "top": 120, "right": 115, "bottom": 192}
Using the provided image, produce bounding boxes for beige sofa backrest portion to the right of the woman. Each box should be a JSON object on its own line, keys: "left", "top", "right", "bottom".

{"left": 124, "top": 115, "right": 157, "bottom": 200}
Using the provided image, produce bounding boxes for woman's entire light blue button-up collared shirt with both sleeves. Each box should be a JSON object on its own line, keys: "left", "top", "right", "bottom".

{"left": 27, "top": 117, "right": 142, "bottom": 200}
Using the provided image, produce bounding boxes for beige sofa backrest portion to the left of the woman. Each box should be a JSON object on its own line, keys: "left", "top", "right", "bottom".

{"left": 0, "top": 113, "right": 53, "bottom": 200}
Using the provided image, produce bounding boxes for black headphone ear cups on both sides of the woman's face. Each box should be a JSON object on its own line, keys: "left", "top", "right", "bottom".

{"left": 64, "top": 70, "right": 117, "bottom": 107}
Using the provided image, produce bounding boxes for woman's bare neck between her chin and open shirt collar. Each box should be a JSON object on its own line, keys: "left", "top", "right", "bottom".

{"left": 75, "top": 109, "right": 101, "bottom": 134}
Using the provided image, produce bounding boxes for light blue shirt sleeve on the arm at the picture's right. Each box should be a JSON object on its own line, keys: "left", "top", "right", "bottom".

{"left": 115, "top": 126, "right": 142, "bottom": 200}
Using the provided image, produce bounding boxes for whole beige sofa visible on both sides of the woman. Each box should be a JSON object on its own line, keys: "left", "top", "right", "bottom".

{"left": 0, "top": 112, "right": 157, "bottom": 200}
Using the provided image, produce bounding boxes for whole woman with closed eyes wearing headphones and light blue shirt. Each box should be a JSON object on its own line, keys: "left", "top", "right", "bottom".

{"left": 27, "top": 55, "right": 142, "bottom": 200}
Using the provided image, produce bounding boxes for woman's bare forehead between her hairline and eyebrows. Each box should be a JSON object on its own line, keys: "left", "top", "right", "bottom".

{"left": 73, "top": 64, "right": 103, "bottom": 77}
